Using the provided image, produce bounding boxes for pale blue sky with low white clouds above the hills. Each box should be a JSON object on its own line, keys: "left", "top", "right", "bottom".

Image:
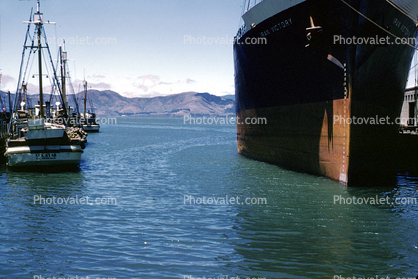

{"left": 0, "top": 0, "right": 243, "bottom": 97}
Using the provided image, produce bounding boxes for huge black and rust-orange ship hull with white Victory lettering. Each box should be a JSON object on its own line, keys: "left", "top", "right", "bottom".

{"left": 234, "top": 0, "right": 417, "bottom": 188}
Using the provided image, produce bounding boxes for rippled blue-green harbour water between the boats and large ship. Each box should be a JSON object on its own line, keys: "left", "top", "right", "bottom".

{"left": 0, "top": 118, "right": 418, "bottom": 279}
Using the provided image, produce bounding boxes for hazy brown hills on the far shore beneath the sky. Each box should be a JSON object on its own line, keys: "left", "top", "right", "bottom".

{"left": 1, "top": 90, "right": 235, "bottom": 116}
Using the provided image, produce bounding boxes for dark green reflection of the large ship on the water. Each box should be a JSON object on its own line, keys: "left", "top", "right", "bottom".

{"left": 230, "top": 162, "right": 418, "bottom": 278}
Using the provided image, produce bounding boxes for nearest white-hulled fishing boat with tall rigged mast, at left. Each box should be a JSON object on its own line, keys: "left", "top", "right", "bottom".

{"left": 4, "top": 0, "right": 84, "bottom": 169}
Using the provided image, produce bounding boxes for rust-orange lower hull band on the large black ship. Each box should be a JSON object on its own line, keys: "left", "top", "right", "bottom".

{"left": 237, "top": 99, "right": 350, "bottom": 184}
